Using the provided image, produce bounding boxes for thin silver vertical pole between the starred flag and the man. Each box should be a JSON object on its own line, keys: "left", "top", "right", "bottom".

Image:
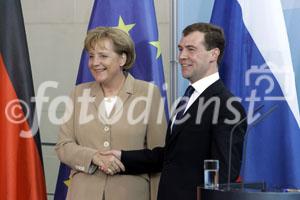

{"left": 169, "top": 0, "right": 178, "bottom": 107}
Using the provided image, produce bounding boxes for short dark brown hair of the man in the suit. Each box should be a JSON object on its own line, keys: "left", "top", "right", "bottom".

{"left": 182, "top": 23, "right": 225, "bottom": 64}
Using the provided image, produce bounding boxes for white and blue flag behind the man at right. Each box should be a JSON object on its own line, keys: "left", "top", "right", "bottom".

{"left": 211, "top": 0, "right": 300, "bottom": 188}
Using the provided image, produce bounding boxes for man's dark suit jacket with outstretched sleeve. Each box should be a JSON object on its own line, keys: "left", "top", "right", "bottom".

{"left": 121, "top": 80, "right": 247, "bottom": 200}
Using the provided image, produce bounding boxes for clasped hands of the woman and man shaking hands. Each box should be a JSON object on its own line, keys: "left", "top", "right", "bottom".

{"left": 92, "top": 150, "right": 125, "bottom": 175}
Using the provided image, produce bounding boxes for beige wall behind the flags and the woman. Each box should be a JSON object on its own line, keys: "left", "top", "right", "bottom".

{"left": 21, "top": 0, "right": 170, "bottom": 199}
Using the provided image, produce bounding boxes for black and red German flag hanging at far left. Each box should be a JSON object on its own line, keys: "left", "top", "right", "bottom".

{"left": 0, "top": 0, "right": 46, "bottom": 200}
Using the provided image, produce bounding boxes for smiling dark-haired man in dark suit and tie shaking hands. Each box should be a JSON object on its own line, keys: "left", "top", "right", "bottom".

{"left": 99, "top": 23, "right": 247, "bottom": 200}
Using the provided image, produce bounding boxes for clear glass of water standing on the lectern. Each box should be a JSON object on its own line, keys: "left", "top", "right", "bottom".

{"left": 204, "top": 160, "right": 219, "bottom": 189}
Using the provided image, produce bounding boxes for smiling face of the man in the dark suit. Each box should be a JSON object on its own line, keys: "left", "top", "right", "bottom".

{"left": 178, "top": 31, "right": 219, "bottom": 83}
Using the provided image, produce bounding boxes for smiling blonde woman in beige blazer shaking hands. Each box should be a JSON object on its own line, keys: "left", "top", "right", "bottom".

{"left": 56, "top": 27, "right": 166, "bottom": 200}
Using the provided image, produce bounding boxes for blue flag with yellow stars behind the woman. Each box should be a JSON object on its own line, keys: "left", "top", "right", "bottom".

{"left": 54, "top": 0, "right": 169, "bottom": 200}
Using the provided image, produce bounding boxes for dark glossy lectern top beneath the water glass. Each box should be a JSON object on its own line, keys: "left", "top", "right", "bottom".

{"left": 197, "top": 187, "right": 300, "bottom": 200}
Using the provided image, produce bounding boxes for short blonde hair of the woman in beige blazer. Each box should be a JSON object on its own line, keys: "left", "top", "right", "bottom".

{"left": 84, "top": 27, "right": 136, "bottom": 70}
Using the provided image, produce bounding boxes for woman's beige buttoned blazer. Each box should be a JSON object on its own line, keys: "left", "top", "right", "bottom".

{"left": 55, "top": 74, "right": 166, "bottom": 200}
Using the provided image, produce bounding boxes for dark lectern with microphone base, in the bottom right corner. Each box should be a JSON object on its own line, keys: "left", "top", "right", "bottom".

{"left": 197, "top": 183, "right": 300, "bottom": 200}
